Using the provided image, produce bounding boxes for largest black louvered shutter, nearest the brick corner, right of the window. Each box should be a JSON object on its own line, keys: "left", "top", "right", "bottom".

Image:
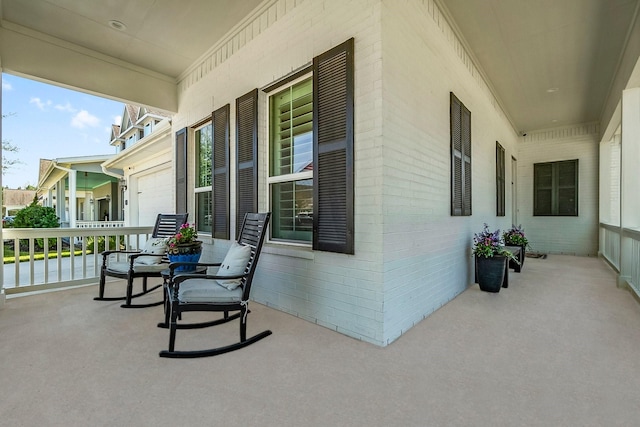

{"left": 313, "top": 39, "right": 354, "bottom": 254}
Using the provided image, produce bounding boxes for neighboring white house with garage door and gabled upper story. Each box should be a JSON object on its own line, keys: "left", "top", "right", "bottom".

{"left": 102, "top": 104, "right": 174, "bottom": 226}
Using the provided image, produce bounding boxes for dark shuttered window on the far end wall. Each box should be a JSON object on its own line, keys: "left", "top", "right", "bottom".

{"left": 533, "top": 159, "right": 578, "bottom": 216}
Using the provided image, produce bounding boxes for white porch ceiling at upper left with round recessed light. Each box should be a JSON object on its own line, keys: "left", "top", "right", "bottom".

{"left": 0, "top": 0, "right": 262, "bottom": 78}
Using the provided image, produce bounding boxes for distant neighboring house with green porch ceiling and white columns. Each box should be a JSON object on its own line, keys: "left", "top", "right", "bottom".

{"left": 38, "top": 155, "right": 123, "bottom": 227}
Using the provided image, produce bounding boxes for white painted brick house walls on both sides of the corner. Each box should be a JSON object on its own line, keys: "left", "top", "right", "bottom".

{"left": 173, "top": 0, "right": 517, "bottom": 346}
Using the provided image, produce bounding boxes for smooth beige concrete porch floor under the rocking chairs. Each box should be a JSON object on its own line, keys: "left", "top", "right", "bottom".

{"left": 0, "top": 255, "right": 640, "bottom": 426}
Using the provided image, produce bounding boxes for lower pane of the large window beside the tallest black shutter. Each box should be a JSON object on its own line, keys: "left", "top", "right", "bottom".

{"left": 271, "top": 179, "right": 313, "bottom": 242}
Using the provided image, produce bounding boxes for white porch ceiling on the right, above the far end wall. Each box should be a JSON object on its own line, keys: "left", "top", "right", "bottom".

{"left": 442, "top": 0, "right": 638, "bottom": 132}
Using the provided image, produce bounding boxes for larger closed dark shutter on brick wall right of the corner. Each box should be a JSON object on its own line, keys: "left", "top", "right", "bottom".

{"left": 450, "top": 92, "right": 471, "bottom": 216}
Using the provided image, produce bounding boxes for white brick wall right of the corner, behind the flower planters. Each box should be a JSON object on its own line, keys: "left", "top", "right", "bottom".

{"left": 382, "top": 0, "right": 517, "bottom": 342}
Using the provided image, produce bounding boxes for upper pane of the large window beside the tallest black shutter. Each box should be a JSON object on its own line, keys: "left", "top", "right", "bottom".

{"left": 270, "top": 79, "right": 313, "bottom": 176}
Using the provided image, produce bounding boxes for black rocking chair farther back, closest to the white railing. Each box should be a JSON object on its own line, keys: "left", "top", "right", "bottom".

{"left": 94, "top": 214, "right": 189, "bottom": 308}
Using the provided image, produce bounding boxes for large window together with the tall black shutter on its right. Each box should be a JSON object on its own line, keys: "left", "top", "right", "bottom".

{"left": 267, "top": 39, "right": 354, "bottom": 254}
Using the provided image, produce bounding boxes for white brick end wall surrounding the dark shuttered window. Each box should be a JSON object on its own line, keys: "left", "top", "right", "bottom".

{"left": 518, "top": 125, "right": 599, "bottom": 256}
